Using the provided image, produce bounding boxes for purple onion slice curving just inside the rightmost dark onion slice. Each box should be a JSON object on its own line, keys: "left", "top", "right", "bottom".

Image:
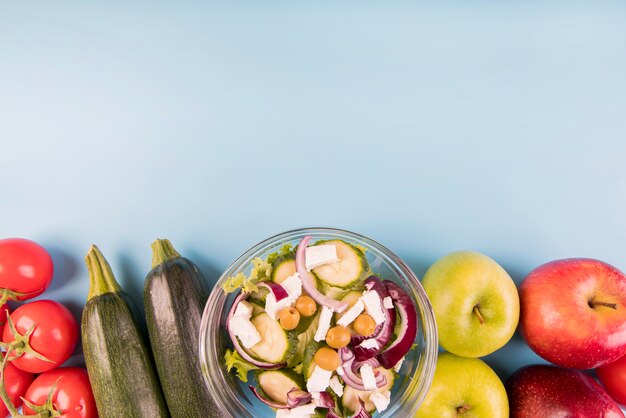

{"left": 350, "top": 276, "right": 396, "bottom": 361}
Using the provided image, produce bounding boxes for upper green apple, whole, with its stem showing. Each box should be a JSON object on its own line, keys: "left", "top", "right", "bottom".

{"left": 422, "top": 251, "right": 520, "bottom": 357}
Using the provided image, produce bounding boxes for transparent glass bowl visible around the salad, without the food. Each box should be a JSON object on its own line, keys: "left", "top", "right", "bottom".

{"left": 199, "top": 228, "right": 438, "bottom": 418}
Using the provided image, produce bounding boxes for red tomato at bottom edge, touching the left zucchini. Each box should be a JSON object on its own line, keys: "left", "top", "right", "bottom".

{"left": 24, "top": 367, "right": 98, "bottom": 418}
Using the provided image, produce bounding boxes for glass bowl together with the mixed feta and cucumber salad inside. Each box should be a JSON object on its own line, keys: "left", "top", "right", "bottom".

{"left": 200, "top": 228, "right": 437, "bottom": 418}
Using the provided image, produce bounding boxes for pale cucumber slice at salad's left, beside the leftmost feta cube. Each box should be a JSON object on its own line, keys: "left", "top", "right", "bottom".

{"left": 249, "top": 312, "right": 298, "bottom": 363}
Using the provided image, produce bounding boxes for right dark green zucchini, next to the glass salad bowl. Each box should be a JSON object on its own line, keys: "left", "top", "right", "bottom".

{"left": 143, "top": 239, "right": 221, "bottom": 418}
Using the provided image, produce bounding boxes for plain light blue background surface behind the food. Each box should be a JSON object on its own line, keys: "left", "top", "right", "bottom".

{"left": 0, "top": 1, "right": 626, "bottom": 404}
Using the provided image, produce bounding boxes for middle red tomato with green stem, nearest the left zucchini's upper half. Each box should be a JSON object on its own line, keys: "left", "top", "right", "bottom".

{"left": 2, "top": 300, "right": 78, "bottom": 373}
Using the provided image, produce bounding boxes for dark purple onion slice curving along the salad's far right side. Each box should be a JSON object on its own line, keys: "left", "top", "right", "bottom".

{"left": 378, "top": 280, "right": 418, "bottom": 369}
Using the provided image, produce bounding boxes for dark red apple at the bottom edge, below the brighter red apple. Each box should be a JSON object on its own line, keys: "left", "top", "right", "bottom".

{"left": 506, "top": 365, "right": 624, "bottom": 418}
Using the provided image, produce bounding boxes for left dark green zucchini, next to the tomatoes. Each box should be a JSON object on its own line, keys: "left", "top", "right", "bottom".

{"left": 81, "top": 245, "right": 169, "bottom": 418}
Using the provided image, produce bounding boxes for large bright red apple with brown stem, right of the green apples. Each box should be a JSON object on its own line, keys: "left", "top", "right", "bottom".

{"left": 519, "top": 258, "right": 626, "bottom": 369}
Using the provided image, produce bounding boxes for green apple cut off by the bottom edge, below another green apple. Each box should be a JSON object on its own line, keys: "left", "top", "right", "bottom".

{"left": 415, "top": 353, "right": 509, "bottom": 418}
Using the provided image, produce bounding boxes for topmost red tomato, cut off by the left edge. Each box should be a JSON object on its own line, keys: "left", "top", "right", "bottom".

{"left": 0, "top": 238, "right": 54, "bottom": 300}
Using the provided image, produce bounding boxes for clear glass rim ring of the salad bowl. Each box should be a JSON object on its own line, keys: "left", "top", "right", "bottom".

{"left": 198, "top": 227, "right": 439, "bottom": 417}
